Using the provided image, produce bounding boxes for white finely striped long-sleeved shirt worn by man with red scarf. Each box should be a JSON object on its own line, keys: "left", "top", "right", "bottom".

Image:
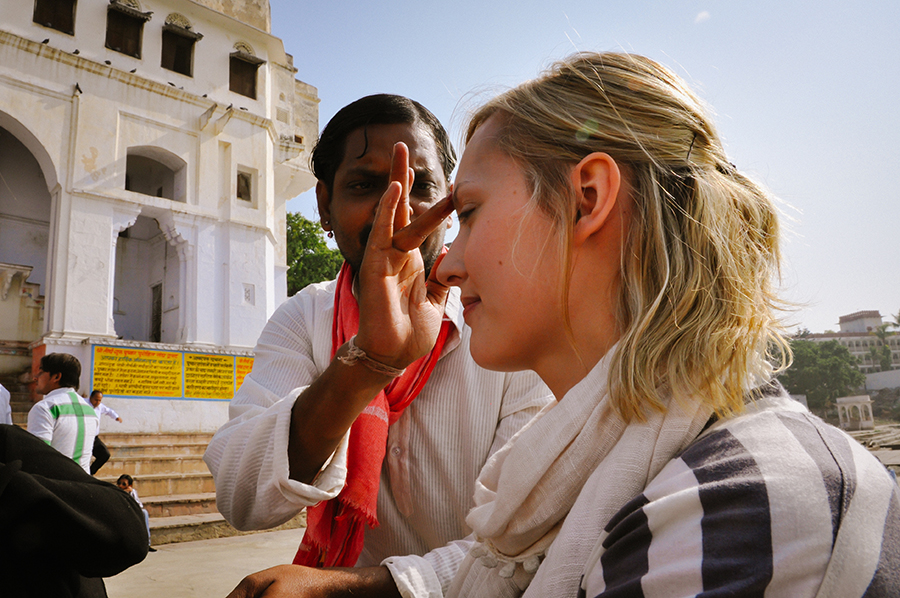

{"left": 204, "top": 282, "right": 552, "bottom": 596}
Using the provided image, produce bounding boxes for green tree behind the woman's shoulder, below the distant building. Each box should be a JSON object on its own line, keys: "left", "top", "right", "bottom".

{"left": 780, "top": 340, "right": 866, "bottom": 415}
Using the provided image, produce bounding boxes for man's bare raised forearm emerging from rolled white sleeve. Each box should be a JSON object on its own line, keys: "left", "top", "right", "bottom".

{"left": 288, "top": 346, "right": 392, "bottom": 484}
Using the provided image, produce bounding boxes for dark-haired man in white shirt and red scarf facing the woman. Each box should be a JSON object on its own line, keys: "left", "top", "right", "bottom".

{"left": 205, "top": 95, "right": 551, "bottom": 596}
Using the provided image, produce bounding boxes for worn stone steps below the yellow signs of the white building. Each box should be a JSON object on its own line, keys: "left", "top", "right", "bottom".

{"left": 0, "top": 377, "right": 306, "bottom": 546}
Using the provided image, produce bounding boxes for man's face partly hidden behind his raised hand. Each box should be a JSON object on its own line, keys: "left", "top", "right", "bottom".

{"left": 316, "top": 124, "right": 449, "bottom": 273}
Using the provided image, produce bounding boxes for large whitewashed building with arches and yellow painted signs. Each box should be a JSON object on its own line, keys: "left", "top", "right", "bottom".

{"left": 0, "top": 0, "right": 319, "bottom": 431}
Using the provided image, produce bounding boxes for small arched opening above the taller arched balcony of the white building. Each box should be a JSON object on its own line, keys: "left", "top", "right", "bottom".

{"left": 125, "top": 145, "right": 187, "bottom": 203}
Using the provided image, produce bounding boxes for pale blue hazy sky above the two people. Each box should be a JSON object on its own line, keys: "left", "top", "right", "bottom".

{"left": 271, "top": 0, "right": 900, "bottom": 332}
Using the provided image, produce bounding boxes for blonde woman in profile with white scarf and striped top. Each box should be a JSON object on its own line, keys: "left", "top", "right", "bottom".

{"left": 229, "top": 53, "right": 900, "bottom": 598}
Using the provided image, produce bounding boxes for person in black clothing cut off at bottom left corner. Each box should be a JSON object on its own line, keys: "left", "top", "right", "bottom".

{"left": 0, "top": 425, "right": 147, "bottom": 598}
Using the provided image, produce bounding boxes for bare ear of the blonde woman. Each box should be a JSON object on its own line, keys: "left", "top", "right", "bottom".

{"left": 572, "top": 152, "right": 621, "bottom": 246}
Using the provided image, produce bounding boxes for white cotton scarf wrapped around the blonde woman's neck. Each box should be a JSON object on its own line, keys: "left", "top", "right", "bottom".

{"left": 448, "top": 347, "right": 712, "bottom": 598}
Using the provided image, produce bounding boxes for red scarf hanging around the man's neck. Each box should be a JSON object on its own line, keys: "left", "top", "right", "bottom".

{"left": 294, "top": 262, "right": 450, "bottom": 567}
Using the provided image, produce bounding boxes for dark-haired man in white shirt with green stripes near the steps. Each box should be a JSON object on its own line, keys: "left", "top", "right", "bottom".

{"left": 28, "top": 353, "right": 100, "bottom": 473}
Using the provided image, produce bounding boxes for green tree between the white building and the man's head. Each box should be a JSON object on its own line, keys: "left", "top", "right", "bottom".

{"left": 287, "top": 213, "right": 344, "bottom": 297}
